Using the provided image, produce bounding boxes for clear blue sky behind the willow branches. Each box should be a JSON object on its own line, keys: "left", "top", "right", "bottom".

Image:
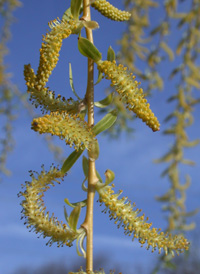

{"left": 0, "top": 0, "right": 200, "bottom": 274}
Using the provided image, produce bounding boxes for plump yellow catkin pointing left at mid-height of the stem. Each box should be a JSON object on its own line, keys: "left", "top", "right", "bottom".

{"left": 32, "top": 112, "right": 95, "bottom": 150}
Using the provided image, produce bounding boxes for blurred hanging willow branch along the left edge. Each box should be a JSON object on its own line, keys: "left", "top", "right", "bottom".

{"left": 0, "top": 0, "right": 21, "bottom": 177}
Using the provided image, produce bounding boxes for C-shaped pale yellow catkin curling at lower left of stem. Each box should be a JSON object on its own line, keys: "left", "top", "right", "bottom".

{"left": 19, "top": 166, "right": 84, "bottom": 247}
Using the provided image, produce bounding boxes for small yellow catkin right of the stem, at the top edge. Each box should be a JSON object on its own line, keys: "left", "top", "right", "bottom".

{"left": 91, "top": 0, "right": 131, "bottom": 21}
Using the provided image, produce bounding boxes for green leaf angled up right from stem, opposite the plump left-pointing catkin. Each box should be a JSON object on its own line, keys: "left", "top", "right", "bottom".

{"left": 93, "top": 110, "right": 117, "bottom": 135}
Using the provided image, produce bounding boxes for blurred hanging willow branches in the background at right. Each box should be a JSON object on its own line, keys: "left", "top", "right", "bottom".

{"left": 119, "top": 0, "right": 200, "bottom": 273}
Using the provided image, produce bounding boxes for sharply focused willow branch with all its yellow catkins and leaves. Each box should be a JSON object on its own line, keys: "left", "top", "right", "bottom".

{"left": 20, "top": 0, "right": 189, "bottom": 273}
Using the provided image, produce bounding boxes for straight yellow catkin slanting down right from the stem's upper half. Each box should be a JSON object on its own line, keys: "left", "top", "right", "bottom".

{"left": 97, "top": 61, "right": 160, "bottom": 131}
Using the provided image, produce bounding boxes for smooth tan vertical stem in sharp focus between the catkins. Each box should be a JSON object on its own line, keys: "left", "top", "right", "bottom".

{"left": 82, "top": 0, "right": 98, "bottom": 272}
